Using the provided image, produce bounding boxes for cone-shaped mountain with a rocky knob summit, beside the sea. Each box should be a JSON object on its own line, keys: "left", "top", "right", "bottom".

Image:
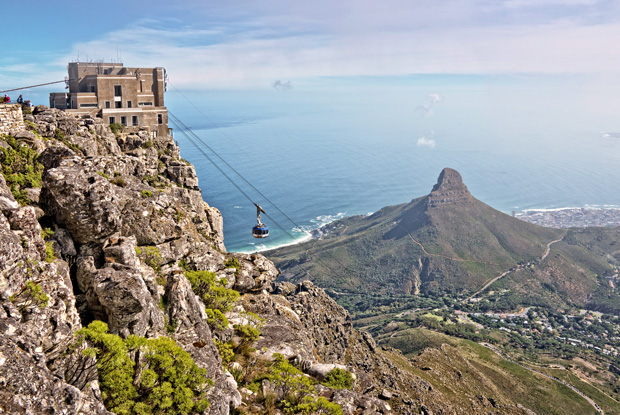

{"left": 266, "top": 168, "right": 616, "bottom": 308}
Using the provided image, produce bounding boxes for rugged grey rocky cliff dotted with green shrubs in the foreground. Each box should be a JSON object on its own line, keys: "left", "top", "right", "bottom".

{"left": 0, "top": 106, "right": 523, "bottom": 414}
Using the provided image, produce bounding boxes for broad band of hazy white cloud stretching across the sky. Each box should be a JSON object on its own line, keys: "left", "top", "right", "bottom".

{"left": 57, "top": 0, "right": 620, "bottom": 88}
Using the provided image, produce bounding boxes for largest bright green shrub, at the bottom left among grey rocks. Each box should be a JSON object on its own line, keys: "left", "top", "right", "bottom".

{"left": 74, "top": 321, "right": 209, "bottom": 415}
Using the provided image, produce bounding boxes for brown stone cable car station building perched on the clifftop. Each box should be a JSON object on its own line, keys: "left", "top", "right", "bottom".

{"left": 50, "top": 62, "right": 169, "bottom": 136}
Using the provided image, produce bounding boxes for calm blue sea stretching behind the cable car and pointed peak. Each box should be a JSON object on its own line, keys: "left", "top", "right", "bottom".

{"left": 166, "top": 76, "right": 620, "bottom": 252}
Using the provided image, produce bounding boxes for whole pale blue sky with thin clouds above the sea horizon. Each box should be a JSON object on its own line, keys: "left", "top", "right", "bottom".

{"left": 0, "top": 0, "right": 620, "bottom": 90}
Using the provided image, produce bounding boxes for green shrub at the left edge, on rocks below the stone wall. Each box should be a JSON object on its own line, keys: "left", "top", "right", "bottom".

{"left": 0, "top": 136, "right": 43, "bottom": 206}
